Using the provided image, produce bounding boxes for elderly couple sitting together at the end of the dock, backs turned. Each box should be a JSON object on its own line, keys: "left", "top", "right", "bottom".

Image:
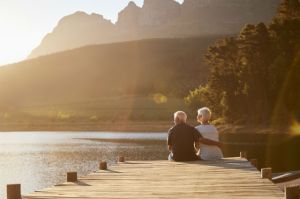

{"left": 168, "top": 107, "right": 223, "bottom": 161}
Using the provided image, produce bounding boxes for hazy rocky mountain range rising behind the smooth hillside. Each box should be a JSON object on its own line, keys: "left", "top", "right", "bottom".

{"left": 29, "top": 0, "right": 280, "bottom": 58}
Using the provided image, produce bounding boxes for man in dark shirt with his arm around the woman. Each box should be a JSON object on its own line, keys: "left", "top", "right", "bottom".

{"left": 167, "top": 111, "right": 220, "bottom": 161}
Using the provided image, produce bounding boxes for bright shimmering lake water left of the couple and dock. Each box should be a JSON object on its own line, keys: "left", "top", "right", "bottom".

{"left": 0, "top": 132, "right": 168, "bottom": 199}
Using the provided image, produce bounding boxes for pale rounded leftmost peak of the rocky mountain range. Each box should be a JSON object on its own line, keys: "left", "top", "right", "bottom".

{"left": 29, "top": 12, "right": 115, "bottom": 58}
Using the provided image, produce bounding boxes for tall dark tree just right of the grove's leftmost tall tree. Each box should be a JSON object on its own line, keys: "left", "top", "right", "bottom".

{"left": 238, "top": 23, "right": 275, "bottom": 122}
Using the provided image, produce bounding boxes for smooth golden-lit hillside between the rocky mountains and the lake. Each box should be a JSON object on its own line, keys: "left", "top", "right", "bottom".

{"left": 0, "top": 36, "right": 219, "bottom": 124}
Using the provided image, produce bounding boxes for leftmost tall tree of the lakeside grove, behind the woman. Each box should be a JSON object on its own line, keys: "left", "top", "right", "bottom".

{"left": 205, "top": 37, "right": 240, "bottom": 119}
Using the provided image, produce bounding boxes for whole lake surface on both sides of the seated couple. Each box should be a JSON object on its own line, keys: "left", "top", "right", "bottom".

{"left": 0, "top": 132, "right": 300, "bottom": 199}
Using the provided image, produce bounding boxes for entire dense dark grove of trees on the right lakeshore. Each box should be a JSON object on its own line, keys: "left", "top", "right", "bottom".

{"left": 185, "top": 0, "right": 300, "bottom": 125}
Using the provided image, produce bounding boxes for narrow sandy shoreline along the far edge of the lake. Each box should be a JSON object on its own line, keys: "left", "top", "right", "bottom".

{"left": 0, "top": 121, "right": 283, "bottom": 134}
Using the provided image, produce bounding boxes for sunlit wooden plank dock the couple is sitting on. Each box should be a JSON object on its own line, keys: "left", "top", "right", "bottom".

{"left": 16, "top": 158, "right": 284, "bottom": 199}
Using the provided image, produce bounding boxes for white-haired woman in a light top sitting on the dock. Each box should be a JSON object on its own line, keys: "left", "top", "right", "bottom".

{"left": 196, "top": 107, "right": 223, "bottom": 160}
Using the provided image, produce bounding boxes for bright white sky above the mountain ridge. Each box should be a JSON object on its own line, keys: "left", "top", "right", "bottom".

{"left": 0, "top": 0, "right": 183, "bottom": 65}
